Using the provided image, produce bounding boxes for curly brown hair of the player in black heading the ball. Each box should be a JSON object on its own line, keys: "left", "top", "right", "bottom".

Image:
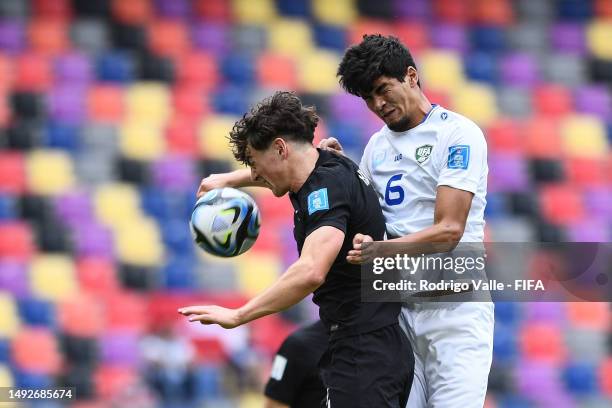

{"left": 229, "top": 91, "right": 319, "bottom": 165}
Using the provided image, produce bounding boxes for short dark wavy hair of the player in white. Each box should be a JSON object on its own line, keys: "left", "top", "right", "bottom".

{"left": 337, "top": 34, "right": 421, "bottom": 97}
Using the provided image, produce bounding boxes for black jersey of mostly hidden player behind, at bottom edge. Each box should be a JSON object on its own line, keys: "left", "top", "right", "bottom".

{"left": 264, "top": 321, "right": 329, "bottom": 408}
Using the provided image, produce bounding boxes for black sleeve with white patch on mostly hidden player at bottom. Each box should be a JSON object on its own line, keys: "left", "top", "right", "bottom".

{"left": 264, "top": 337, "right": 316, "bottom": 405}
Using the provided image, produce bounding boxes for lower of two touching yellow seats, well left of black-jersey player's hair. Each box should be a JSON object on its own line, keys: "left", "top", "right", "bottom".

{"left": 119, "top": 120, "right": 166, "bottom": 160}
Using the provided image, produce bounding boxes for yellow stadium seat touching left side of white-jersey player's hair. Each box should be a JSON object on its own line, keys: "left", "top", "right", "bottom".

{"left": 298, "top": 51, "right": 340, "bottom": 93}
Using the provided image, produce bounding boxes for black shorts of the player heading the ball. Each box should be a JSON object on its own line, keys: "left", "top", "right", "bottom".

{"left": 319, "top": 324, "right": 414, "bottom": 408}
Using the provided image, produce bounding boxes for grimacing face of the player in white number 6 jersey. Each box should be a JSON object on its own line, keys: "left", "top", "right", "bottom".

{"left": 363, "top": 67, "right": 418, "bottom": 132}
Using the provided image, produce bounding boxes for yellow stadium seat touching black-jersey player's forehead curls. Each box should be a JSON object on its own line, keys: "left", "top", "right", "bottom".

{"left": 198, "top": 115, "right": 238, "bottom": 162}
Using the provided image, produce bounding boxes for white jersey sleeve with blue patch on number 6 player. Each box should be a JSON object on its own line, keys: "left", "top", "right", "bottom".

{"left": 438, "top": 124, "right": 487, "bottom": 194}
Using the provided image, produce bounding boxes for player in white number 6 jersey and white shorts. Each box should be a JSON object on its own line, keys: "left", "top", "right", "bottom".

{"left": 320, "top": 35, "right": 494, "bottom": 408}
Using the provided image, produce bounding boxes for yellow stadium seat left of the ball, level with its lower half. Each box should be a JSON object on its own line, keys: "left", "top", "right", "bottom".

{"left": 115, "top": 217, "right": 164, "bottom": 266}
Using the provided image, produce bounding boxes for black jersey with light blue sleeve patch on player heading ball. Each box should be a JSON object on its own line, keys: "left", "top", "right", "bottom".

{"left": 289, "top": 150, "right": 400, "bottom": 337}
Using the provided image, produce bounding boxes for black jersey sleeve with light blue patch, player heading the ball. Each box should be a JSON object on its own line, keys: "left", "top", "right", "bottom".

{"left": 304, "top": 172, "right": 350, "bottom": 236}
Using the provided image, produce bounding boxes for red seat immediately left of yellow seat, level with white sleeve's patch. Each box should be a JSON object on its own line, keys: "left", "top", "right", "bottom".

{"left": 521, "top": 117, "right": 562, "bottom": 159}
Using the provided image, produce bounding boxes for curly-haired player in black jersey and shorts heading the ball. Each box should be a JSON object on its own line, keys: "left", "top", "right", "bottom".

{"left": 179, "top": 92, "right": 414, "bottom": 408}
